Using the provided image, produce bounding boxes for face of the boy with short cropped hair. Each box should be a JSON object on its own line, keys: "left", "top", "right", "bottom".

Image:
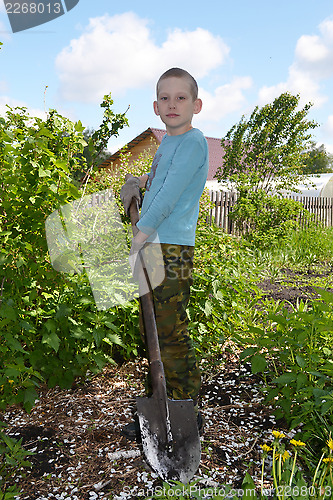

{"left": 154, "top": 76, "right": 202, "bottom": 135}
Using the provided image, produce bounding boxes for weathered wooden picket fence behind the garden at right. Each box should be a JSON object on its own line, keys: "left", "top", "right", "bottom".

{"left": 207, "top": 191, "right": 333, "bottom": 235}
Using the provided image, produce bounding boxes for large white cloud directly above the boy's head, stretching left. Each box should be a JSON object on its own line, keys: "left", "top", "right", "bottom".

{"left": 56, "top": 12, "right": 229, "bottom": 102}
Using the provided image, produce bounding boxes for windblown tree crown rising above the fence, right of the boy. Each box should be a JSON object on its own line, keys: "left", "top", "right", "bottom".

{"left": 215, "top": 92, "right": 318, "bottom": 193}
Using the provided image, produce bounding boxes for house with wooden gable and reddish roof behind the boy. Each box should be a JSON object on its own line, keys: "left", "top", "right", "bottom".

{"left": 100, "top": 127, "right": 224, "bottom": 189}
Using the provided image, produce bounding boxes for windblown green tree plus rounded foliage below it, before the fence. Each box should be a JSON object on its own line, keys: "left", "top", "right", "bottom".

{"left": 215, "top": 92, "right": 318, "bottom": 245}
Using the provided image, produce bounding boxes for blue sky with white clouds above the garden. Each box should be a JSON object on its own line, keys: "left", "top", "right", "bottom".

{"left": 0, "top": 0, "right": 333, "bottom": 153}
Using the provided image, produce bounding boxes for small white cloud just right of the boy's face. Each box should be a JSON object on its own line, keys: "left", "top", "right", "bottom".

{"left": 198, "top": 77, "right": 252, "bottom": 122}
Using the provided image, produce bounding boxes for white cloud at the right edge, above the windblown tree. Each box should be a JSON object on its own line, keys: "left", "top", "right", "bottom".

{"left": 259, "top": 19, "right": 333, "bottom": 108}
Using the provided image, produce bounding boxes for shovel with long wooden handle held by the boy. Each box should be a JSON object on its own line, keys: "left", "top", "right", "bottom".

{"left": 129, "top": 194, "right": 201, "bottom": 483}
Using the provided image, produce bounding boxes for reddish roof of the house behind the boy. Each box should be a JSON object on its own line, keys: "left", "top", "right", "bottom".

{"left": 100, "top": 127, "right": 224, "bottom": 181}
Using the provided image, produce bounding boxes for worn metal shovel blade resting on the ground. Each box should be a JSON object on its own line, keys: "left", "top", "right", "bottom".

{"left": 136, "top": 395, "right": 201, "bottom": 483}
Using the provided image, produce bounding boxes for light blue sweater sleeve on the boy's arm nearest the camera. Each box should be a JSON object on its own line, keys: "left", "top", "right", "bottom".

{"left": 137, "top": 138, "right": 206, "bottom": 235}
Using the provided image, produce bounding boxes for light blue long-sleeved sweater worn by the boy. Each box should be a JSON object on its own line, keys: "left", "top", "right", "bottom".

{"left": 137, "top": 128, "right": 208, "bottom": 246}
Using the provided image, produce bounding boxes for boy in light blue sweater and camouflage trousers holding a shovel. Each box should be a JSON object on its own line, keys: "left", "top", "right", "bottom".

{"left": 121, "top": 68, "right": 208, "bottom": 439}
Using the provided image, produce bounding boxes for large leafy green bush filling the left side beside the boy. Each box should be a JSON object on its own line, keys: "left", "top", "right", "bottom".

{"left": 0, "top": 100, "right": 135, "bottom": 410}
